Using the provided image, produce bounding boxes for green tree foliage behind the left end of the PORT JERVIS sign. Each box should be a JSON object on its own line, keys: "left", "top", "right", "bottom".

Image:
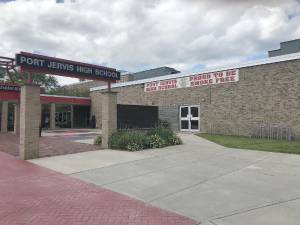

{"left": 8, "top": 71, "right": 59, "bottom": 92}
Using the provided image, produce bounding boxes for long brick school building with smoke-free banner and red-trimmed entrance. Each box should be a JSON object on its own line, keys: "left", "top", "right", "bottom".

{"left": 0, "top": 53, "right": 300, "bottom": 139}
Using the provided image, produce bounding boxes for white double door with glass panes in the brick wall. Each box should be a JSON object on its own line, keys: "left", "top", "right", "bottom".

{"left": 179, "top": 105, "right": 200, "bottom": 131}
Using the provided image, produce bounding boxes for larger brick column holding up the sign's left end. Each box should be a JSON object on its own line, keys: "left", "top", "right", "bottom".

{"left": 20, "top": 84, "right": 41, "bottom": 160}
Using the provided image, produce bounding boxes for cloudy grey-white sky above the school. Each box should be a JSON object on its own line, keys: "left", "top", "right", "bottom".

{"left": 0, "top": 0, "right": 300, "bottom": 83}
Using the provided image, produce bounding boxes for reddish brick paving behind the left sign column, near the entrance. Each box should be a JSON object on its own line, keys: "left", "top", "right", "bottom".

{"left": 0, "top": 133, "right": 100, "bottom": 158}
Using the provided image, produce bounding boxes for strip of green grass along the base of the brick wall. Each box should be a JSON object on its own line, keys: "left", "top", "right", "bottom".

{"left": 198, "top": 134, "right": 300, "bottom": 154}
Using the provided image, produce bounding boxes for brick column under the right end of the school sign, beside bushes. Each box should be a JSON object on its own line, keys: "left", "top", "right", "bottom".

{"left": 101, "top": 92, "right": 117, "bottom": 148}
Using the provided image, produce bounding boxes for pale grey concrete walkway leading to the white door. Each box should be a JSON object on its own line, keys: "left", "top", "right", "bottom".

{"left": 29, "top": 134, "right": 300, "bottom": 225}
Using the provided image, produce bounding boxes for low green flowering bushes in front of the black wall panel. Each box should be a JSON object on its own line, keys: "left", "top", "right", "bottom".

{"left": 108, "top": 128, "right": 182, "bottom": 151}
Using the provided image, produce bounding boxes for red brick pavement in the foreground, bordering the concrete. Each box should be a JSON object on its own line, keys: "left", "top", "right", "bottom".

{"left": 0, "top": 152, "right": 197, "bottom": 225}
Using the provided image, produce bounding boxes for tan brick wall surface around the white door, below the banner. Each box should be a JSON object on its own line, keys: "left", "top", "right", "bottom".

{"left": 91, "top": 60, "right": 300, "bottom": 139}
